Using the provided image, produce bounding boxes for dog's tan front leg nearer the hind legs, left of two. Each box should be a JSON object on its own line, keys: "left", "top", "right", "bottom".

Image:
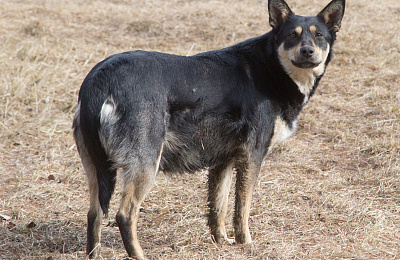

{"left": 208, "top": 163, "right": 234, "bottom": 244}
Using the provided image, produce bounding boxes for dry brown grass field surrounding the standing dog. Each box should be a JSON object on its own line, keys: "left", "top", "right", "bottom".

{"left": 0, "top": 0, "right": 400, "bottom": 260}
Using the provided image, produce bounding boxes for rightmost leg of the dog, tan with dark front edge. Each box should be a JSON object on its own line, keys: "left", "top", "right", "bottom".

{"left": 233, "top": 161, "right": 260, "bottom": 244}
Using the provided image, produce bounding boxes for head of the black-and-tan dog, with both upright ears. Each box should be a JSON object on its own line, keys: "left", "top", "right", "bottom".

{"left": 268, "top": 0, "right": 345, "bottom": 73}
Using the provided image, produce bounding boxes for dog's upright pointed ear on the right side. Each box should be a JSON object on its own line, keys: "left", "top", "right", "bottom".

{"left": 317, "top": 0, "right": 346, "bottom": 33}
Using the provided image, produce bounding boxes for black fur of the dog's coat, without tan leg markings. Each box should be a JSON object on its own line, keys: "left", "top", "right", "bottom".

{"left": 74, "top": 0, "right": 344, "bottom": 257}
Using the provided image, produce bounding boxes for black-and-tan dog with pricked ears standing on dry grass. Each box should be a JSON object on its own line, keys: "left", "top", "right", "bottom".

{"left": 73, "top": 0, "right": 345, "bottom": 259}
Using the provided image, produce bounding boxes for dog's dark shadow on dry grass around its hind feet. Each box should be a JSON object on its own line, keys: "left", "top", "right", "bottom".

{"left": 0, "top": 216, "right": 184, "bottom": 259}
